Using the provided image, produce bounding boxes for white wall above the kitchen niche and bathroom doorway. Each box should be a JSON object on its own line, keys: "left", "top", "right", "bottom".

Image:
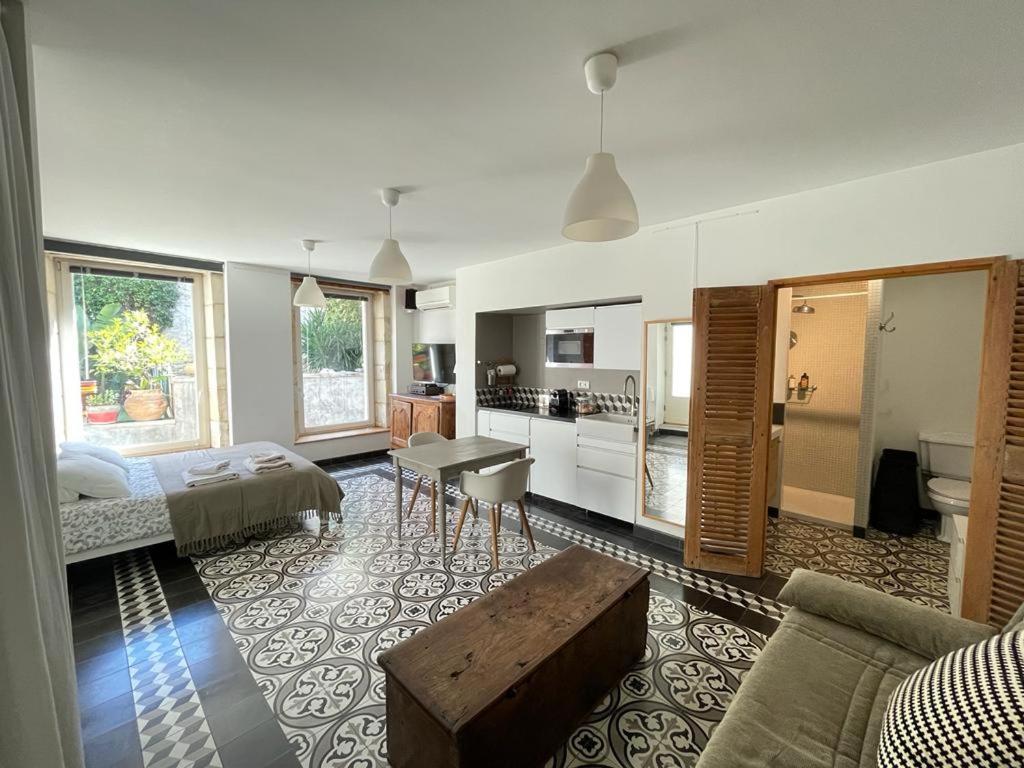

{"left": 456, "top": 144, "right": 1024, "bottom": 442}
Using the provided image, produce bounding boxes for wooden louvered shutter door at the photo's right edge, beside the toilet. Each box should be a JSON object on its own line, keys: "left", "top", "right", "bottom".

{"left": 961, "top": 261, "right": 1024, "bottom": 628}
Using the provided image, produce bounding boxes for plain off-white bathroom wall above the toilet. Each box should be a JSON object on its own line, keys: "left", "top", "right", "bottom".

{"left": 874, "top": 272, "right": 987, "bottom": 458}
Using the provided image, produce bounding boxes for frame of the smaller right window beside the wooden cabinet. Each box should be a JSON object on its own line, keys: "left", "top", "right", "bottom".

{"left": 291, "top": 281, "right": 377, "bottom": 442}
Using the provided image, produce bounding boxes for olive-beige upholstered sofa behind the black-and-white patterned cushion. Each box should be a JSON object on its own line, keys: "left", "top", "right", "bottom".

{"left": 697, "top": 570, "right": 1024, "bottom": 768}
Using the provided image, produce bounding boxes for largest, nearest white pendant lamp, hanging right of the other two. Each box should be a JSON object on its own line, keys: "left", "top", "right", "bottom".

{"left": 562, "top": 53, "right": 640, "bottom": 243}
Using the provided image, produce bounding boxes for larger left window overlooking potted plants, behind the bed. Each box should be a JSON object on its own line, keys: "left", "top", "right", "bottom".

{"left": 53, "top": 258, "right": 210, "bottom": 455}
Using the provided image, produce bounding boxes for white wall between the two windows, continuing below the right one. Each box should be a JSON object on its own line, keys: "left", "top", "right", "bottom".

{"left": 224, "top": 262, "right": 390, "bottom": 460}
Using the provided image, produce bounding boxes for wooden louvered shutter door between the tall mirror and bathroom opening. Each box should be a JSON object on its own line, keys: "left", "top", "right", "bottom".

{"left": 684, "top": 286, "right": 775, "bottom": 575}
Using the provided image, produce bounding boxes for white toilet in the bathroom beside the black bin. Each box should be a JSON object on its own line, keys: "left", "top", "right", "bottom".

{"left": 918, "top": 432, "right": 974, "bottom": 542}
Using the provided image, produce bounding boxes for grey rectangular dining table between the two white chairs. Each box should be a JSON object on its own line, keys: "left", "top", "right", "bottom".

{"left": 388, "top": 435, "right": 529, "bottom": 563}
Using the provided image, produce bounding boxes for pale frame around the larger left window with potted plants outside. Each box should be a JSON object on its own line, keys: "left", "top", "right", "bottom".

{"left": 52, "top": 252, "right": 212, "bottom": 457}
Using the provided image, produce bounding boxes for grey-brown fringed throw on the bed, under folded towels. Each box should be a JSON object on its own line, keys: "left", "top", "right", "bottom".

{"left": 153, "top": 442, "right": 342, "bottom": 557}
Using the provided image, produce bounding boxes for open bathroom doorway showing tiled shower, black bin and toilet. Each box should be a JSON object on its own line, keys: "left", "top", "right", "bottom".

{"left": 765, "top": 268, "right": 989, "bottom": 614}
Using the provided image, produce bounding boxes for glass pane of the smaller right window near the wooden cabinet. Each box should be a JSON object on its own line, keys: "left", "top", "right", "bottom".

{"left": 295, "top": 290, "right": 374, "bottom": 437}
